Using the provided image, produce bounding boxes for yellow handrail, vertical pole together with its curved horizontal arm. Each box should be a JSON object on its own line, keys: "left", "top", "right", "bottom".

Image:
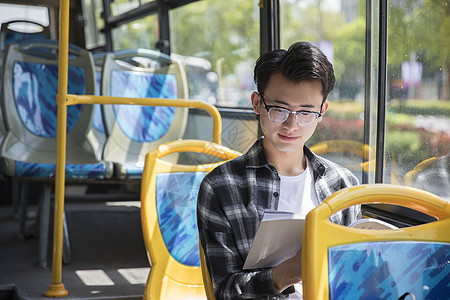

{"left": 44, "top": 0, "right": 222, "bottom": 297}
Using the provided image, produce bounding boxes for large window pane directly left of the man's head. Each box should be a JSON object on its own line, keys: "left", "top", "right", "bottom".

{"left": 170, "top": 0, "right": 259, "bottom": 107}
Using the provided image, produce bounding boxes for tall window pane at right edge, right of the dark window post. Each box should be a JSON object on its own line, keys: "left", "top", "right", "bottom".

{"left": 384, "top": 0, "right": 450, "bottom": 199}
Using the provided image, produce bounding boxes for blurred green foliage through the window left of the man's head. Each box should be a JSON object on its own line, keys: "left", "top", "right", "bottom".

{"left": 171, "top": 0, "right": 259, "bottom": 73}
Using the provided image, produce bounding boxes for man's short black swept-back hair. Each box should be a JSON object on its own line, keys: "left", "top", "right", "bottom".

{"left": 254, "top": 42, "right": 336, "bottom": 101}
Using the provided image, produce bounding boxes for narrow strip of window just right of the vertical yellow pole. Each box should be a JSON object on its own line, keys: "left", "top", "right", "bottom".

{"left": 83, "top": 0, "right": 105, "bottom": 49}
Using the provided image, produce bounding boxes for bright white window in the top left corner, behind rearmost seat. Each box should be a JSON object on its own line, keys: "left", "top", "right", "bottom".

{"left": 0, "top": 4, "right": 49, "bottom": 27}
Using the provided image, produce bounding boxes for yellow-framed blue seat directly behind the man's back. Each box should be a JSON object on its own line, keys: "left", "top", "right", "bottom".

{"left": 141, "top": 140, "right": 241, "bottom": 299}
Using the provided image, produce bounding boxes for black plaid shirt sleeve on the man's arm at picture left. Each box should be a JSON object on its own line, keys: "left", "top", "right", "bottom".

{"left": 197, "top": 178, "right": 286, "bottom": 299}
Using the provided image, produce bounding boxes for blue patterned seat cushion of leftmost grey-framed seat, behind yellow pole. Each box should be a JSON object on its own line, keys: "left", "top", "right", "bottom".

{"left": 15, "top": 161, "right": 110, "bottom": 179}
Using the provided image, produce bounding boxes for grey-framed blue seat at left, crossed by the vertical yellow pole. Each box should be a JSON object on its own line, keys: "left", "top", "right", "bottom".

{"left": 0, "top": 41, "right": 113, "bottom": 267}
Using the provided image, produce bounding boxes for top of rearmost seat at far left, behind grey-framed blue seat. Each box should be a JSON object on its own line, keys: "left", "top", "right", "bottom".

{"left": 0, "top": 20, "right": 50, "bottom": 51}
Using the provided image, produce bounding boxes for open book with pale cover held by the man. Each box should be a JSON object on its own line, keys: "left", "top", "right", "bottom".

{"left": 243, "top": 210, "right": 398, "bottom": 270}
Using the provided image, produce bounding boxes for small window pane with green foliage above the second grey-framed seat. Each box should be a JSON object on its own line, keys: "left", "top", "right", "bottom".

{"left": 112, "top": 15, "right": 158, "bottom": 51}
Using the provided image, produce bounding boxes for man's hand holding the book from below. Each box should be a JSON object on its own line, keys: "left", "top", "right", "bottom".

{"left": 272, "top": 250, "right": 302, "bottom": 292}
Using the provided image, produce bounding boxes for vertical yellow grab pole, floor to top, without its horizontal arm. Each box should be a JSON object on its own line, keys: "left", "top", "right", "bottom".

{"left": 44, "top": 0, "right": 69, "bottom": 297}
